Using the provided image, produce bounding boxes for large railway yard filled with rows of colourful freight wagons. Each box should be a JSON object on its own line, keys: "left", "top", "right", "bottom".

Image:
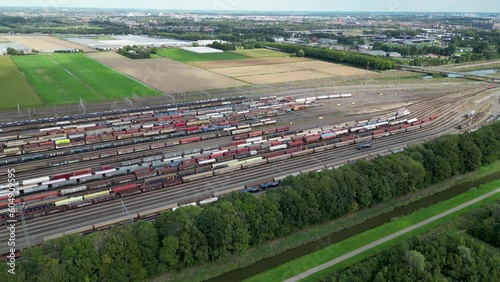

{"left": 0, "top": 81, "right": 500, "bottom": 253}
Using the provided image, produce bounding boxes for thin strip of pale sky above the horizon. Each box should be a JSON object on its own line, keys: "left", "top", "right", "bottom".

{"left": 0, "top": 0, "right": 500, "bottom": 12}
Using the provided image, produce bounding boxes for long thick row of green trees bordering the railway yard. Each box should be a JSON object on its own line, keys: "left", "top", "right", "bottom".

{"left": 0, "top": 123, "right": 500, "bottom": 281}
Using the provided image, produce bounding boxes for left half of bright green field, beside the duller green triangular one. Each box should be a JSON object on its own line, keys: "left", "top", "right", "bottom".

{"left": 12, "top": 56, "right": 101, "bottom": 105}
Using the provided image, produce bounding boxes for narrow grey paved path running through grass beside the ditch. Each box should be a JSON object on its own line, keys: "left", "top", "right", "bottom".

{"left": 285, "top": 188, "right": 500, "bottom": 282}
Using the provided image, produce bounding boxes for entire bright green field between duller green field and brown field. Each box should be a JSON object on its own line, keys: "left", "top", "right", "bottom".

{"left": 13, "top": 54, "right": 158, "bottom": 105}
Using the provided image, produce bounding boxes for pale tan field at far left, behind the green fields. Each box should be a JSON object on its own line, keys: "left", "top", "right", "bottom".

{"left": 2, "top": 35, "right": 94, "bottom": 52}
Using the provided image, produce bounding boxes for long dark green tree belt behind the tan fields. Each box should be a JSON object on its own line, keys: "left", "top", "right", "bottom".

{"left": 265, "top": 43, "right": 396, "bottom": 70}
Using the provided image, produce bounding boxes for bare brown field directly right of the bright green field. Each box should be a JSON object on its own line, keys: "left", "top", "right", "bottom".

{"left": 87, "top": 52, "right": 246, "bottom": 93}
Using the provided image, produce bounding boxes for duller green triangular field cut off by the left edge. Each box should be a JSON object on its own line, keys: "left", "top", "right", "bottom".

{"left": 0, "top": 56, "right": 43, "bottom": 110}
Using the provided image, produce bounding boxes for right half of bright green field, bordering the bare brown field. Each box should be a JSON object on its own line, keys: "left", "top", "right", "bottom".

{"left": 52, "top": 54, "right": 158, "bottom": 100}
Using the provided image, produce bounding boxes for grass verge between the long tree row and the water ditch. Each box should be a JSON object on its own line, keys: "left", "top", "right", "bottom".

{"left": 156, "top": 161, "right": 500, "bottom": 281}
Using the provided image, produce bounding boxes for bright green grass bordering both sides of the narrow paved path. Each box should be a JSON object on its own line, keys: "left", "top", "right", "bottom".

{"left": 249, "top": 180, "right": 500, "bottom": 281}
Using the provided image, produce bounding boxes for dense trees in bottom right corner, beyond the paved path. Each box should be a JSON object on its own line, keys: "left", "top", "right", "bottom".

{"left": 322, "top": 202, "right": 500, "bottom": 282}
